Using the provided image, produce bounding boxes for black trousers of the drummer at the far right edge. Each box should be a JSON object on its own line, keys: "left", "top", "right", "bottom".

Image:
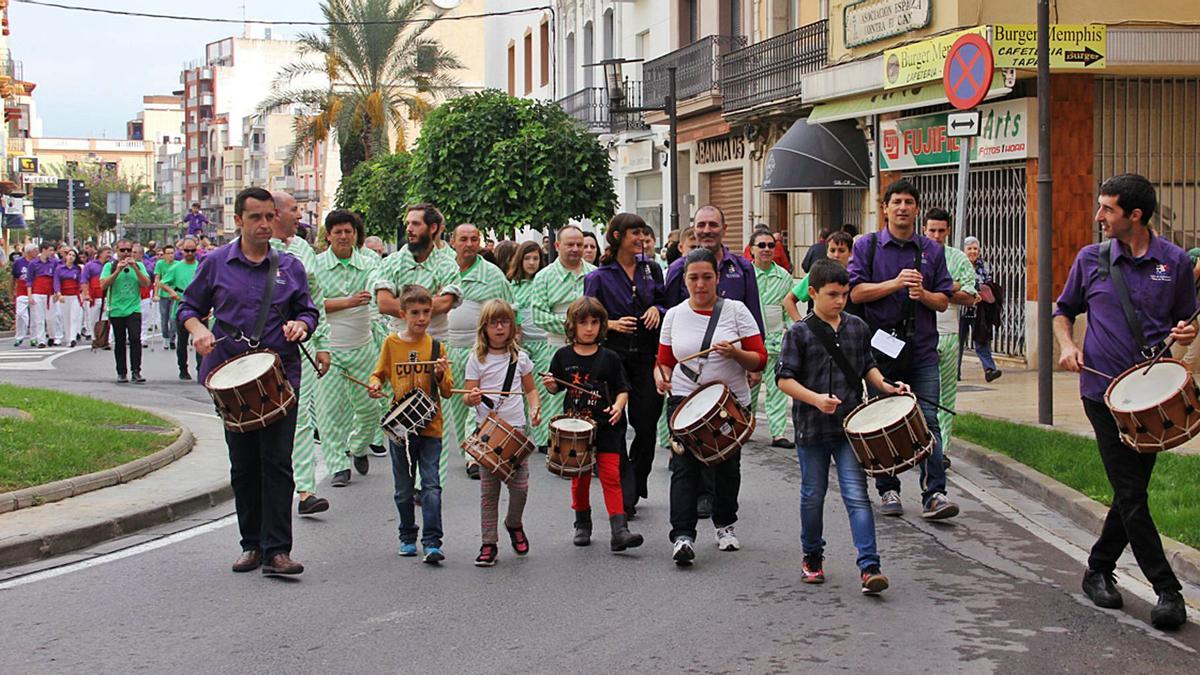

{"left": 1084, "top": 399, "right": 1183, "bottom": 593}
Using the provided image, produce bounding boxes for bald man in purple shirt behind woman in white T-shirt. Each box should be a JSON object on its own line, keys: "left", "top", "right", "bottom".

{"left": 659, "top": 204, "right": 766, "bottom": 518}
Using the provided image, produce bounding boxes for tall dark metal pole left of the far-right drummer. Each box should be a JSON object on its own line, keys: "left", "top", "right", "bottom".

{"left": 1038, "top": 0, "right": 1054, "bottom": 424}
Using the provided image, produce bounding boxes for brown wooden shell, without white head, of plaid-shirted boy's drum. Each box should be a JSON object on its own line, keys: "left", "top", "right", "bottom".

{"left": 842, "top": 394, "right": 934, "bottom": 477}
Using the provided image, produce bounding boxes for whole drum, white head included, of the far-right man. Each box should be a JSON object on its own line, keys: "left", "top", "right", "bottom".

{"left": 1104, "top": 359, "right": 1200, "bottom": 453}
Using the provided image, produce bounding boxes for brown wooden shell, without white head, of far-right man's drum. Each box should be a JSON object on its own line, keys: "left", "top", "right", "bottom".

{"left": 1104, "top": 359, "right": 1200, "bottom": 454}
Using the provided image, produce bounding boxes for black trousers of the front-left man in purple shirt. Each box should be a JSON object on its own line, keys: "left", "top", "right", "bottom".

{"left": 226, "top": 401, "right": 300, "bottom": 560}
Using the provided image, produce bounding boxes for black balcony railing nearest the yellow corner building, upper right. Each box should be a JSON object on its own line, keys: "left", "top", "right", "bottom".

{"left": 721, "top": 20, "right": 828, "bottom": 113}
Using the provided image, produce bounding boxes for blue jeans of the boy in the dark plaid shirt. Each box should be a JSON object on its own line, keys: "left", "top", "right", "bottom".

{"left": 796, "top": 438, "right": 880, "bottom": 569}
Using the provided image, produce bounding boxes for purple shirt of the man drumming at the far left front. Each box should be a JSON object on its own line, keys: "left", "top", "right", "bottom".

{"left": 179, "top": 239, "right": 317, "bottom": 393}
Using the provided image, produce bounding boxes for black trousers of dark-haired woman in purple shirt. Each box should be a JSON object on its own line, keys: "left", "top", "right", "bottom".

{"left": 619, "top": 353, "right": 662, "bottom": 513}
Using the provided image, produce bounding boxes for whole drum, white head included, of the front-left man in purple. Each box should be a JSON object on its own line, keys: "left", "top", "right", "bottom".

{"left": 204, "top": 350, "right": 296, "bottom": 434}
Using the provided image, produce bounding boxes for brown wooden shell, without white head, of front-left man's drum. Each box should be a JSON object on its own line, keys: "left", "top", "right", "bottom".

{"left": 204, "top": 350, "right": 296, "bottom": 434}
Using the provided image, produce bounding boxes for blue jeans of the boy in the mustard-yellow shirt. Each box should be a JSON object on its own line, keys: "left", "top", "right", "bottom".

{"left": 388, "top": 436, "right": 442, "bottom": 548}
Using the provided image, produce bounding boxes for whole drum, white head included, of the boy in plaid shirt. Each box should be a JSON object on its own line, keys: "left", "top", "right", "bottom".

{"left": 842, "top": 394, "right": 934, "bottom": 477}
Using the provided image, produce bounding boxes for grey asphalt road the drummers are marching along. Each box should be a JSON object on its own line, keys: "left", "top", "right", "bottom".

{"left": 0, "top": 336, "right": 1200, "bottom": 673}
